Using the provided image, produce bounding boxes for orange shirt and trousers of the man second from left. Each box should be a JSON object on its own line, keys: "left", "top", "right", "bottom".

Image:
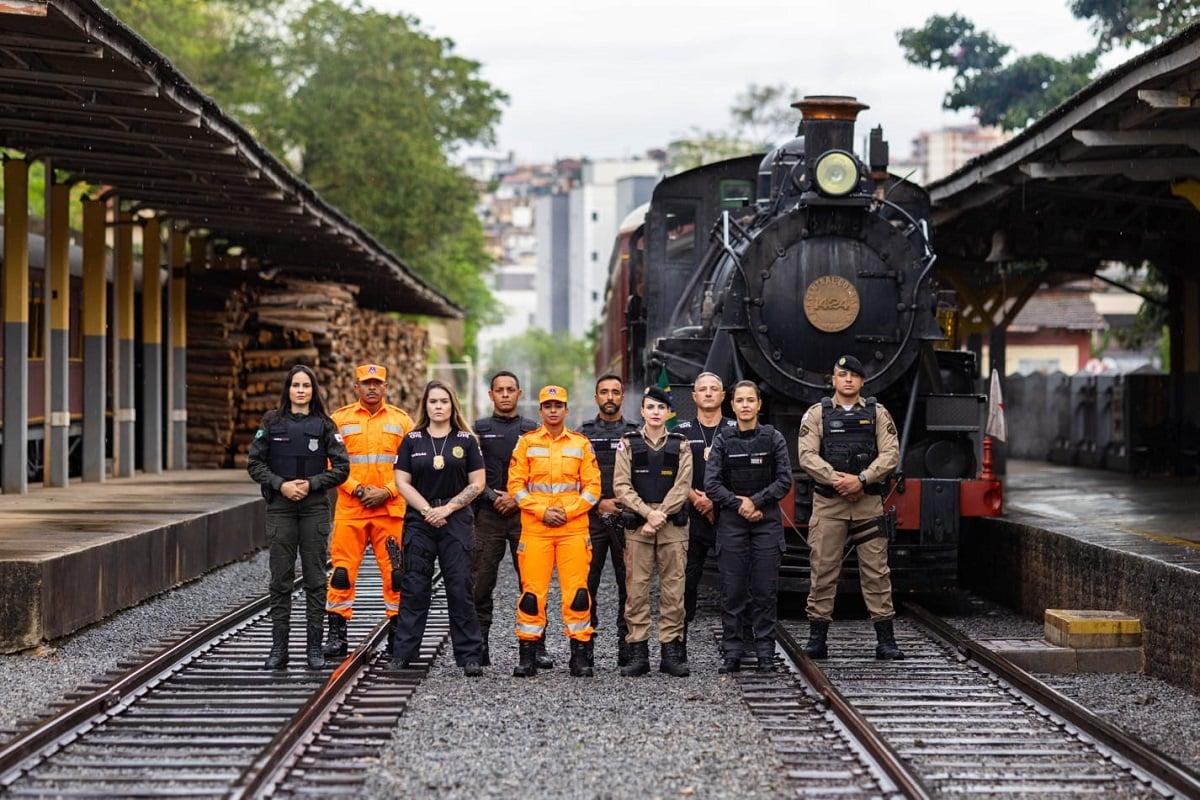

{"left": 325, "top": 403, "right": 413, "bottom": 619}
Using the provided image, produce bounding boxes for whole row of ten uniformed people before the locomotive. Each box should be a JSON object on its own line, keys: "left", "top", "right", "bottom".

{"left": 250, "top": 356, "right": 902, "bottom": 676}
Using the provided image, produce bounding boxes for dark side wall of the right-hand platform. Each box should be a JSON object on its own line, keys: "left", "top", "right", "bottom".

{"left": 959, "top": 516, "right": 1200, "bottom": 692}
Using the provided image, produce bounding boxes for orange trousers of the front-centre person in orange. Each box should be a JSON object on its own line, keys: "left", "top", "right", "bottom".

{"left": 516, "top": 529, "right": 592, "bottom": 642}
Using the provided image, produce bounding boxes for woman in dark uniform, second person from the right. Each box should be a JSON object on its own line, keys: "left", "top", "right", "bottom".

{"left": 704, "top": 380, "right": 792, "bottom": 673}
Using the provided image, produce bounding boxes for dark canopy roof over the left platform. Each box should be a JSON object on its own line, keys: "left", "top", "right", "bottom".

{"left": 0, "top": 0, "right": 462, "bottom": 317}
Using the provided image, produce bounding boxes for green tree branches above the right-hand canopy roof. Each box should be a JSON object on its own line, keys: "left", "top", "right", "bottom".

{"left": 896, "top": 0, "right": 1200, "bottom": 131}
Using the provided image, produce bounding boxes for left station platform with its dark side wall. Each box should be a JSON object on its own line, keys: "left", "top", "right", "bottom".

{"left": 0, "top": 469, "right": 265, "bottom": 652}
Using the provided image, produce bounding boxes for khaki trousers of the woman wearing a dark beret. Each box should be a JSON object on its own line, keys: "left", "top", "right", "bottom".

{"left": 625, "top": 536, "right": 688, "bottom": 644}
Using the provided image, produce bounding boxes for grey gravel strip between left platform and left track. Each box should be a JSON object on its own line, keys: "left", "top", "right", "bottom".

{"left": 0, "top": 551, "right": 269, "bottom": 741}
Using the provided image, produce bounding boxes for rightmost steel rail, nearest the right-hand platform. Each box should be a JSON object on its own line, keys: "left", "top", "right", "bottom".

{"left": 901, "top": 601, "right": 1200, "bottom": 798}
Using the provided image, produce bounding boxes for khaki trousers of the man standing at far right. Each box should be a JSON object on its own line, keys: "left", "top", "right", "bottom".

{"left": 806, "top": 512, "right": 895, "bottom": 622}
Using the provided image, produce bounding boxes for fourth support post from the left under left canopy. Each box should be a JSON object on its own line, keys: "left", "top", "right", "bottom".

{"left": 113, "top": 209, "right": 137, "bottom": 477}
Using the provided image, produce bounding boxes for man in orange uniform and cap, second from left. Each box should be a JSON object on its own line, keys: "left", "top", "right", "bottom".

{"left": 324, "top": 363, "right": 413, "bottom": 656}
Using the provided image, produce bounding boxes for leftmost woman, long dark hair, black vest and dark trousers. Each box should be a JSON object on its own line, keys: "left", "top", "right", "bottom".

{"left": 246, "top": 365, "right": 350, "bottom": 669}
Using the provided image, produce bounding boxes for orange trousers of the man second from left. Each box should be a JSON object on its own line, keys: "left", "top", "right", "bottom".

{"left": 325, "top": 515, "right": 404, "bottom": 619}
